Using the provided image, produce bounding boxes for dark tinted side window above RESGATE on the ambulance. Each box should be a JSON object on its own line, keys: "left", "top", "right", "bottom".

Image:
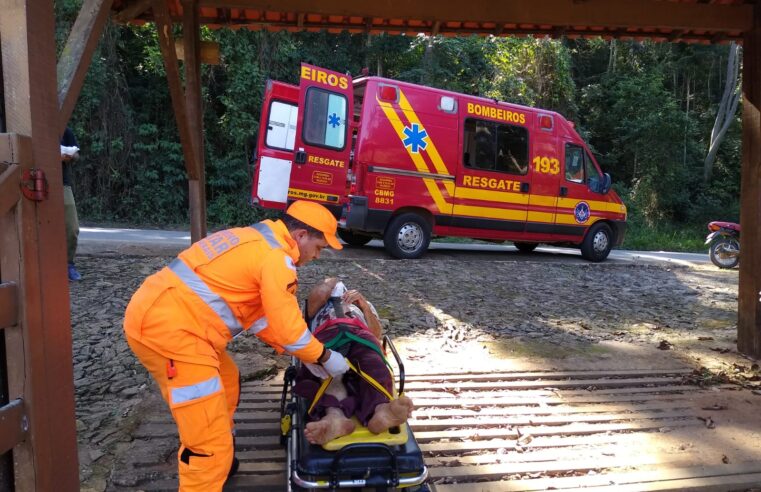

{"left": 463, "top": 118, "right": 528, "bottom": 174}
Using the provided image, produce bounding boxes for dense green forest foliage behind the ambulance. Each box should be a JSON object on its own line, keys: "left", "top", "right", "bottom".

{"left": 56, "top": 13, "right": 741, "bottom": 242}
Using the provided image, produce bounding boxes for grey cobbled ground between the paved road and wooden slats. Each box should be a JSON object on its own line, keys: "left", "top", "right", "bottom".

{"left": 71, "top": 255, "right": 759, "bottom": 490}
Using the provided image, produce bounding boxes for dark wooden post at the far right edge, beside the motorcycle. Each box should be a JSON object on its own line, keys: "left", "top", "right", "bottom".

{"left": 737, "top": 3, "right": 761, "bottom": 358}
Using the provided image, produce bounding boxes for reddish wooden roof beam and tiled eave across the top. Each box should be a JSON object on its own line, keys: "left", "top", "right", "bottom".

{"left": 113, "top": 0, "right": 753, "bottom": 44}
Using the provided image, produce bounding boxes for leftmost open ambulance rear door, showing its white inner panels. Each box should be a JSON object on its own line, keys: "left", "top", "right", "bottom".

{"left": 251, "top": 81, "right": 299, "bottom": 209}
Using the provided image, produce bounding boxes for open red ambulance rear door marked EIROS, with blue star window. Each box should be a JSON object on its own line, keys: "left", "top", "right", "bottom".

{"left": 288, "top": 63, "right": 353, "bottom": 216}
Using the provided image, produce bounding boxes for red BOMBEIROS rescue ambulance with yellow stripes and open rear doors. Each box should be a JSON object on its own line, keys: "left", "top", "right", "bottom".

{"left": 252, "top": 64, "right": 626, "bottom": 261}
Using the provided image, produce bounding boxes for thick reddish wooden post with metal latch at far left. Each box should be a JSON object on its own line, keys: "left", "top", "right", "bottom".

{"left": 0, "top": 0, "right": 79, "bottom": 491}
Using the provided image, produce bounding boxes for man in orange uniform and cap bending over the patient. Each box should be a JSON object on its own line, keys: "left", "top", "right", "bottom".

{"left": 124, "top": 201, "right": 348, "bottom": 492}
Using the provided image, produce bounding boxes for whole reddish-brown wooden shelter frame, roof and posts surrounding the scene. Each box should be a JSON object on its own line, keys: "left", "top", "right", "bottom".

{"left": 0, "top": 0, "right": 761, "bottom": 491}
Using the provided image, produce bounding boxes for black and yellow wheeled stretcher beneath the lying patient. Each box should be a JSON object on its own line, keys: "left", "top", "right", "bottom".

{"left": 280, "top": 336, "right": 429, "bottom": 492}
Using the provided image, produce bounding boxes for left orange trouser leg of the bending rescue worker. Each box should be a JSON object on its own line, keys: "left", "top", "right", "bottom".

{"left": 127, "top": 337, "right": 233, "bottom": 492}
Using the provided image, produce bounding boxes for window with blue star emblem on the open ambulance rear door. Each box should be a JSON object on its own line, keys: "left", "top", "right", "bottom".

{"left": 302, "top": 87, "right": 348, "bottom": 150}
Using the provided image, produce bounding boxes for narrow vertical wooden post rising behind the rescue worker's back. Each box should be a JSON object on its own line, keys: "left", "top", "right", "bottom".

{"left": 182, "top": 0, "right": 206, "bottom": 242}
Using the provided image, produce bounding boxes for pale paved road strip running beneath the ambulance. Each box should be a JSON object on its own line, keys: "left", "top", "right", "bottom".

{"left": 78, "top": 227, "right": 710, "bottom": 265}
